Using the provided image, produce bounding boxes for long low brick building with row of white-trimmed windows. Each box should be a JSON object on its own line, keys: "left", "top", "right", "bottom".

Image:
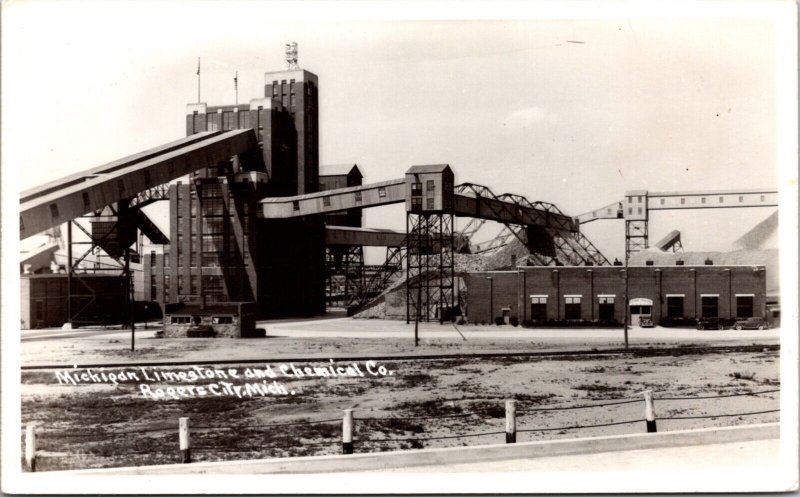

{"left": 465, "top": 265, "right": 766, "bottom": 324}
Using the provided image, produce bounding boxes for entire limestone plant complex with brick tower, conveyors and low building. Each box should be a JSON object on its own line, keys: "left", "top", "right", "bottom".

{"left": 20, "top": 45, "right": 777, "bottom": 336}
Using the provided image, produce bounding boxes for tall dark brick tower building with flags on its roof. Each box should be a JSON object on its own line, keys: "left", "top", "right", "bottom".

{"left": 164, "top": 65, "right": 326, "bottom": 317}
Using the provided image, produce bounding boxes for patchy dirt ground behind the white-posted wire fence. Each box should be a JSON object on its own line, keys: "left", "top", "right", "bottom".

{"left": 22, "top": 346, "right": 780, "bottom": 470}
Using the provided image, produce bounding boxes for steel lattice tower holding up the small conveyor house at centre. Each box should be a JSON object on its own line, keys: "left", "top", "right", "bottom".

{"left": 406, "top": 212, "right": 455, "bottom": 323}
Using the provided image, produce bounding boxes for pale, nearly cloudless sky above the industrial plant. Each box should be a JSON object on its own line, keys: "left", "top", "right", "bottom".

{"left": 2, "top": 1, "right": 788, "bottom": 258}
